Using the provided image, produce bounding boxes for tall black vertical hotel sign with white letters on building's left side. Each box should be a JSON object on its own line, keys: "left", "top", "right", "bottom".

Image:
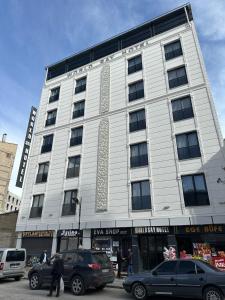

{"left": 16, "top": 106, "right": 37, "bottom": 188}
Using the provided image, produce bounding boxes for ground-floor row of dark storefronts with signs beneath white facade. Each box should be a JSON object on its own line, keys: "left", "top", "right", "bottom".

{"left": 18, "top": 224, "right": 225, "bottom": 272}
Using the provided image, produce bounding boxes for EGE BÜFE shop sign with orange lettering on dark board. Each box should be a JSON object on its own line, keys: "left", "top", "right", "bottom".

{"left": 174, "top": 224, "right": 225, "bottom": 234}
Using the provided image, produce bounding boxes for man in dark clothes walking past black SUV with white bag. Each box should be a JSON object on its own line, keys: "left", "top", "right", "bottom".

{"left": 48, "top": 253, "right": 64, "bottom": 297}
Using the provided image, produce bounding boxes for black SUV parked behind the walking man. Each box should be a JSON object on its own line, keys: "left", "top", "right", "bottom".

{"left": 28, "top": 250, "right": 114, "bottom": 295}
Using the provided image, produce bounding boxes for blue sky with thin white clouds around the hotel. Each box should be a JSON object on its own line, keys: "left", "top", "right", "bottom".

{"left": 0, "top": 0, "right": 225, "bottom": 194}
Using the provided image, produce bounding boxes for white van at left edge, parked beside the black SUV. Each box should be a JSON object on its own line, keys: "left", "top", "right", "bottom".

{"left": 0, "top": 248, "right": 26, "bottom": 280}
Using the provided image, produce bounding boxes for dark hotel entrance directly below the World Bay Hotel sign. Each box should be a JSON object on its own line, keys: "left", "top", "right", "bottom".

{"left": 139, "top": 235, "right": 167, "bottom": 270}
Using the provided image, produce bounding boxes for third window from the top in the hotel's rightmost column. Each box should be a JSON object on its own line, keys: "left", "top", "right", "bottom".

{"left": 171, "top": 96, "right": 194, "bottom": 122}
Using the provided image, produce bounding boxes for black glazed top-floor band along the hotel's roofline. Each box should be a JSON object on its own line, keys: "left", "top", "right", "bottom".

{"left": 46, "top": 4, "right": 193, "bottom": 80}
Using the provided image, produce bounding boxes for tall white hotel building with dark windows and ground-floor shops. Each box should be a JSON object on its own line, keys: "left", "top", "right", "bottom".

{"left": 17, "top": 5, "right": 225, "bottom": 270}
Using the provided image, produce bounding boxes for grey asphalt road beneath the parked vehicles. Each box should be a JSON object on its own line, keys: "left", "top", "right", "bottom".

{"left": 0, "top": 279, "right": 197, "bottom": 300}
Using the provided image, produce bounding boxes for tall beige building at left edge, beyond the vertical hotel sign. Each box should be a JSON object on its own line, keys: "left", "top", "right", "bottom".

{"left": 0, "top": 134, "right": 17, "bottom": 213}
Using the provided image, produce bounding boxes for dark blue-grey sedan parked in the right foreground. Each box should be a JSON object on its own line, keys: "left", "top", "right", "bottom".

{"left": 123, "top": 259, "right": 225, "bottom": 300}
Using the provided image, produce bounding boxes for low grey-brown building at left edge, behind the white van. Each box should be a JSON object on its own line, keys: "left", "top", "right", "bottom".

{"left": 0, "top": 211, "right": 18, "bottom": 248}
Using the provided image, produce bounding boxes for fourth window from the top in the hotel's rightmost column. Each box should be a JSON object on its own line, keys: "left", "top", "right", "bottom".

{"left": 176, "top": 131, "right": 201, "bottom": 160}
